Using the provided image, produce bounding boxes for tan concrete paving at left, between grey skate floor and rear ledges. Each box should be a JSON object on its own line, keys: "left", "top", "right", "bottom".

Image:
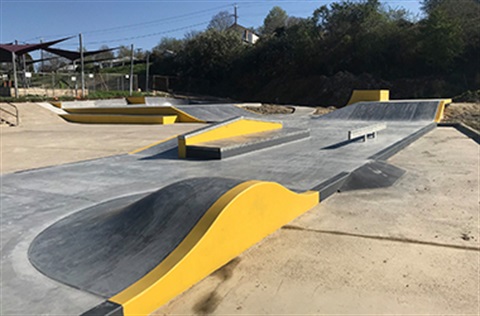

{"left": 0, "top": 103, "right": 205, "bottom": 174}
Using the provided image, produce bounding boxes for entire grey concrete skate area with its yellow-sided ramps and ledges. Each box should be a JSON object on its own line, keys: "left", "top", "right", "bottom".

{"left": 2, "top": 90, "right": 479, "bottom": 315}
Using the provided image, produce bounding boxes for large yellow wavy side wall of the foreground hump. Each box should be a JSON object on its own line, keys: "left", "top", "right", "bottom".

{"left": 109, "top": 181, "right": 319, "bottom": 316}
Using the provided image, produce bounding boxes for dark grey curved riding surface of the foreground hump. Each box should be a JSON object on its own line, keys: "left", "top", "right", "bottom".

{"left": 29, "top": 178, "right": 243, "bottom": 297}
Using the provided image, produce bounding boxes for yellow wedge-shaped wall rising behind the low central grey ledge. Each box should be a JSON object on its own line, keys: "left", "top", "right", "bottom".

{"left": 178, "top": 117, "right": 283, "bottom": 158}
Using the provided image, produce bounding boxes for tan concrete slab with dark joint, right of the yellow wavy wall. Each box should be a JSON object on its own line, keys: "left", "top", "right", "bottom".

{"left": 153, "top": 128, "right": 480, "bottom": 316}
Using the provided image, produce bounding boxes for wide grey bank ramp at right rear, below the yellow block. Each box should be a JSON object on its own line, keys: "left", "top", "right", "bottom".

{"left": 321, "top": 100, "right": 443, "bottom": 121}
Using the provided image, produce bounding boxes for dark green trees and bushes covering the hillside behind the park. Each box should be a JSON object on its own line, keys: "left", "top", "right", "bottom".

{"left": 151, "top": 0, "right": 480, "bottom": 106}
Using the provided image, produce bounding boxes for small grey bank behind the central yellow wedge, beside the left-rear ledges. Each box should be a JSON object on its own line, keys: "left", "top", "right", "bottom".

{"left": 175, "top": 104, "right": 258, "bottom": 122}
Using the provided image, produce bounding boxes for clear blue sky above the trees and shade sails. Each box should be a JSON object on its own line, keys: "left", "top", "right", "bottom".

{"left": 0, "top": 0, "right": 420, "bottom": 54}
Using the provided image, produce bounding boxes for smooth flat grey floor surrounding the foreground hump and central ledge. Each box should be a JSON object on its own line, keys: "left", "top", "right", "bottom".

{"left": 1, "top": 99, "right": 450, "bottom": 314}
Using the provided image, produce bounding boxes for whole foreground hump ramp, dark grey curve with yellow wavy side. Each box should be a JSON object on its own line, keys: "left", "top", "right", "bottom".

{"left": 28, "top": 178, "right": 319, "bottom": 315}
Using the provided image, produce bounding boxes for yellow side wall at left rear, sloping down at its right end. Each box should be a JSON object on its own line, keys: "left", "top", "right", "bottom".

{"left": 64, "top": 106, "right": 206, "bottom": 123}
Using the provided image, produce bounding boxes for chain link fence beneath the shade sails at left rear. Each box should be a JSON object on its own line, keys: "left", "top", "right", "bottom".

{"left": 0, "top": 72, "right": 138, "bottom": 97}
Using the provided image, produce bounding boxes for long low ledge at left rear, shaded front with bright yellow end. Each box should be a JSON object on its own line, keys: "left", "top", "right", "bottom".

{"left": 60, "top": 114, "right": 177, "bottom": 124}
